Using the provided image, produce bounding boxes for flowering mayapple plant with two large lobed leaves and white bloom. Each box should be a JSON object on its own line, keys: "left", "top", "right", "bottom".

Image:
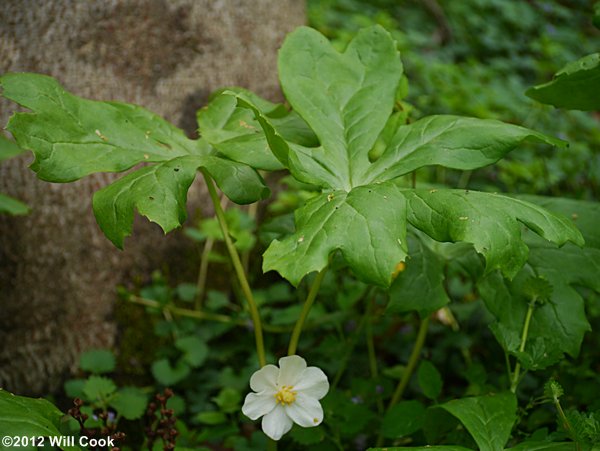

{"left": 0, "top": 26, "right": 587, "bottom": 449}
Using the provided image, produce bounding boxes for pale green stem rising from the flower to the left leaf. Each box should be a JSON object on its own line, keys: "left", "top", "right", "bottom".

{"left": 200, "top": 169, "right": 267, "bottom": 367}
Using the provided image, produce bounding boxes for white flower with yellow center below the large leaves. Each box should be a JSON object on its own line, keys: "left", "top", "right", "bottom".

{"left": 242, "top": 355, "right": 329, "bottom": 440}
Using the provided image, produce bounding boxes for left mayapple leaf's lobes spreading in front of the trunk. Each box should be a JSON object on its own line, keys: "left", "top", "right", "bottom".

{"left": 0, "top": 73, "right": 268, "bottom": 248}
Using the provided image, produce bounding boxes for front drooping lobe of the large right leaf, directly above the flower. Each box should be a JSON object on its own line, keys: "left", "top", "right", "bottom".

{"left": 263, "top": 183, "right": 406, "bottom": 286}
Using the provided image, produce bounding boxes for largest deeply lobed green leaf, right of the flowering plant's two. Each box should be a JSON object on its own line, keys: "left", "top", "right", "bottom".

{"left": 234, "top": 27, "right": 582, "bottom": 286}
